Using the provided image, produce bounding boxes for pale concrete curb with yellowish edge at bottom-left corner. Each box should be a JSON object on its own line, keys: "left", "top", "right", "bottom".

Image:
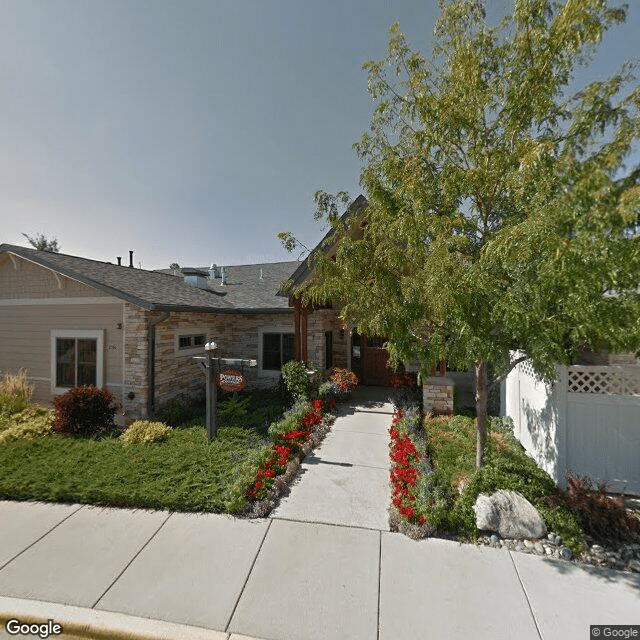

{"left": 0, "top": 596, "right": 248, "bottom": 640}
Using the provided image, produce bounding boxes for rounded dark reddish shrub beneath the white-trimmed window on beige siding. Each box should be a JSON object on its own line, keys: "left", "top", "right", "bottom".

{"left": 53, "top": 386, "right": 116, "bottom": 435}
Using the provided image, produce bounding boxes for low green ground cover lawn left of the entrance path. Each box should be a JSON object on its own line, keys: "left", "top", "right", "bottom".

{"left": 0, "top": 384, "right": 288, "bottom": 512}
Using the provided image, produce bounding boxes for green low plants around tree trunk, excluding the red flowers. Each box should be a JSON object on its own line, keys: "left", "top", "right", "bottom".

{"left": 416, "top": 416, "right": 582, "bottom": 554}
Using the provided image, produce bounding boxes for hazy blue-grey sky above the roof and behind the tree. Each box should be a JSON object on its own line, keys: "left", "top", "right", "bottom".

{"left": 0, "top": 0, "right": 640, "bottom": 269}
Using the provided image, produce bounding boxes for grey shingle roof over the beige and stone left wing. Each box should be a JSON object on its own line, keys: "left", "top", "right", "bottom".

{"left": 0, "top": 244, "right": 299, "bottom": 313}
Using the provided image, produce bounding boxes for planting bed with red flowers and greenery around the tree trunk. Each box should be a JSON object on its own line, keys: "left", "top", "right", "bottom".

{"left": 389, "top": 409, "right": 581, "bottom": 554}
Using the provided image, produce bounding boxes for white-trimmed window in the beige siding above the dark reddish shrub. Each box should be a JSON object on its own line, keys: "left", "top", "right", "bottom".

{"left": 51, "top": 329, "right": 104, "bottom": 393}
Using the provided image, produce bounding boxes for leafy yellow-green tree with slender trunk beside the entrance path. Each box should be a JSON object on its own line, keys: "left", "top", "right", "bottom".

{"left": 280, "top": 0, "right": 640, "bottom": 466}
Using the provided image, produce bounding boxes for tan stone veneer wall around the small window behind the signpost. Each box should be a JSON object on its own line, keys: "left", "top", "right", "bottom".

{"left": 124, "top": 304, "right": 293, "bottom": 421}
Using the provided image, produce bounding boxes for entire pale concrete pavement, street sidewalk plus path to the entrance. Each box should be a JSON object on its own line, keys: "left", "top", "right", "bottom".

{"left": 0, "top": 388, "right": 640, "bottom": 640}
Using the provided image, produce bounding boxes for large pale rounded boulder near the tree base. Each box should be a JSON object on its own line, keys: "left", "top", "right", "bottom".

{"left": 473, "top": 489, "right": 547, "bottom": 540}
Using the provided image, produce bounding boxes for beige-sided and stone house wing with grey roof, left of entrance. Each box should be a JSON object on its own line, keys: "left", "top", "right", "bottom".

{"left": 0, "top": 244, "right": 299, "bottom": 421}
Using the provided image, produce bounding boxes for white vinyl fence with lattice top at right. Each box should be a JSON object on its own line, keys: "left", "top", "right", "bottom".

{"left": 502, "top": 361, "right": 640, "bottom": 494}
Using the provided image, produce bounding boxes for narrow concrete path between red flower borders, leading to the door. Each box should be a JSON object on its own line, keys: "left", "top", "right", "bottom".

{"left": 271, "top": 387, "right": 393, "bottom": 531}
